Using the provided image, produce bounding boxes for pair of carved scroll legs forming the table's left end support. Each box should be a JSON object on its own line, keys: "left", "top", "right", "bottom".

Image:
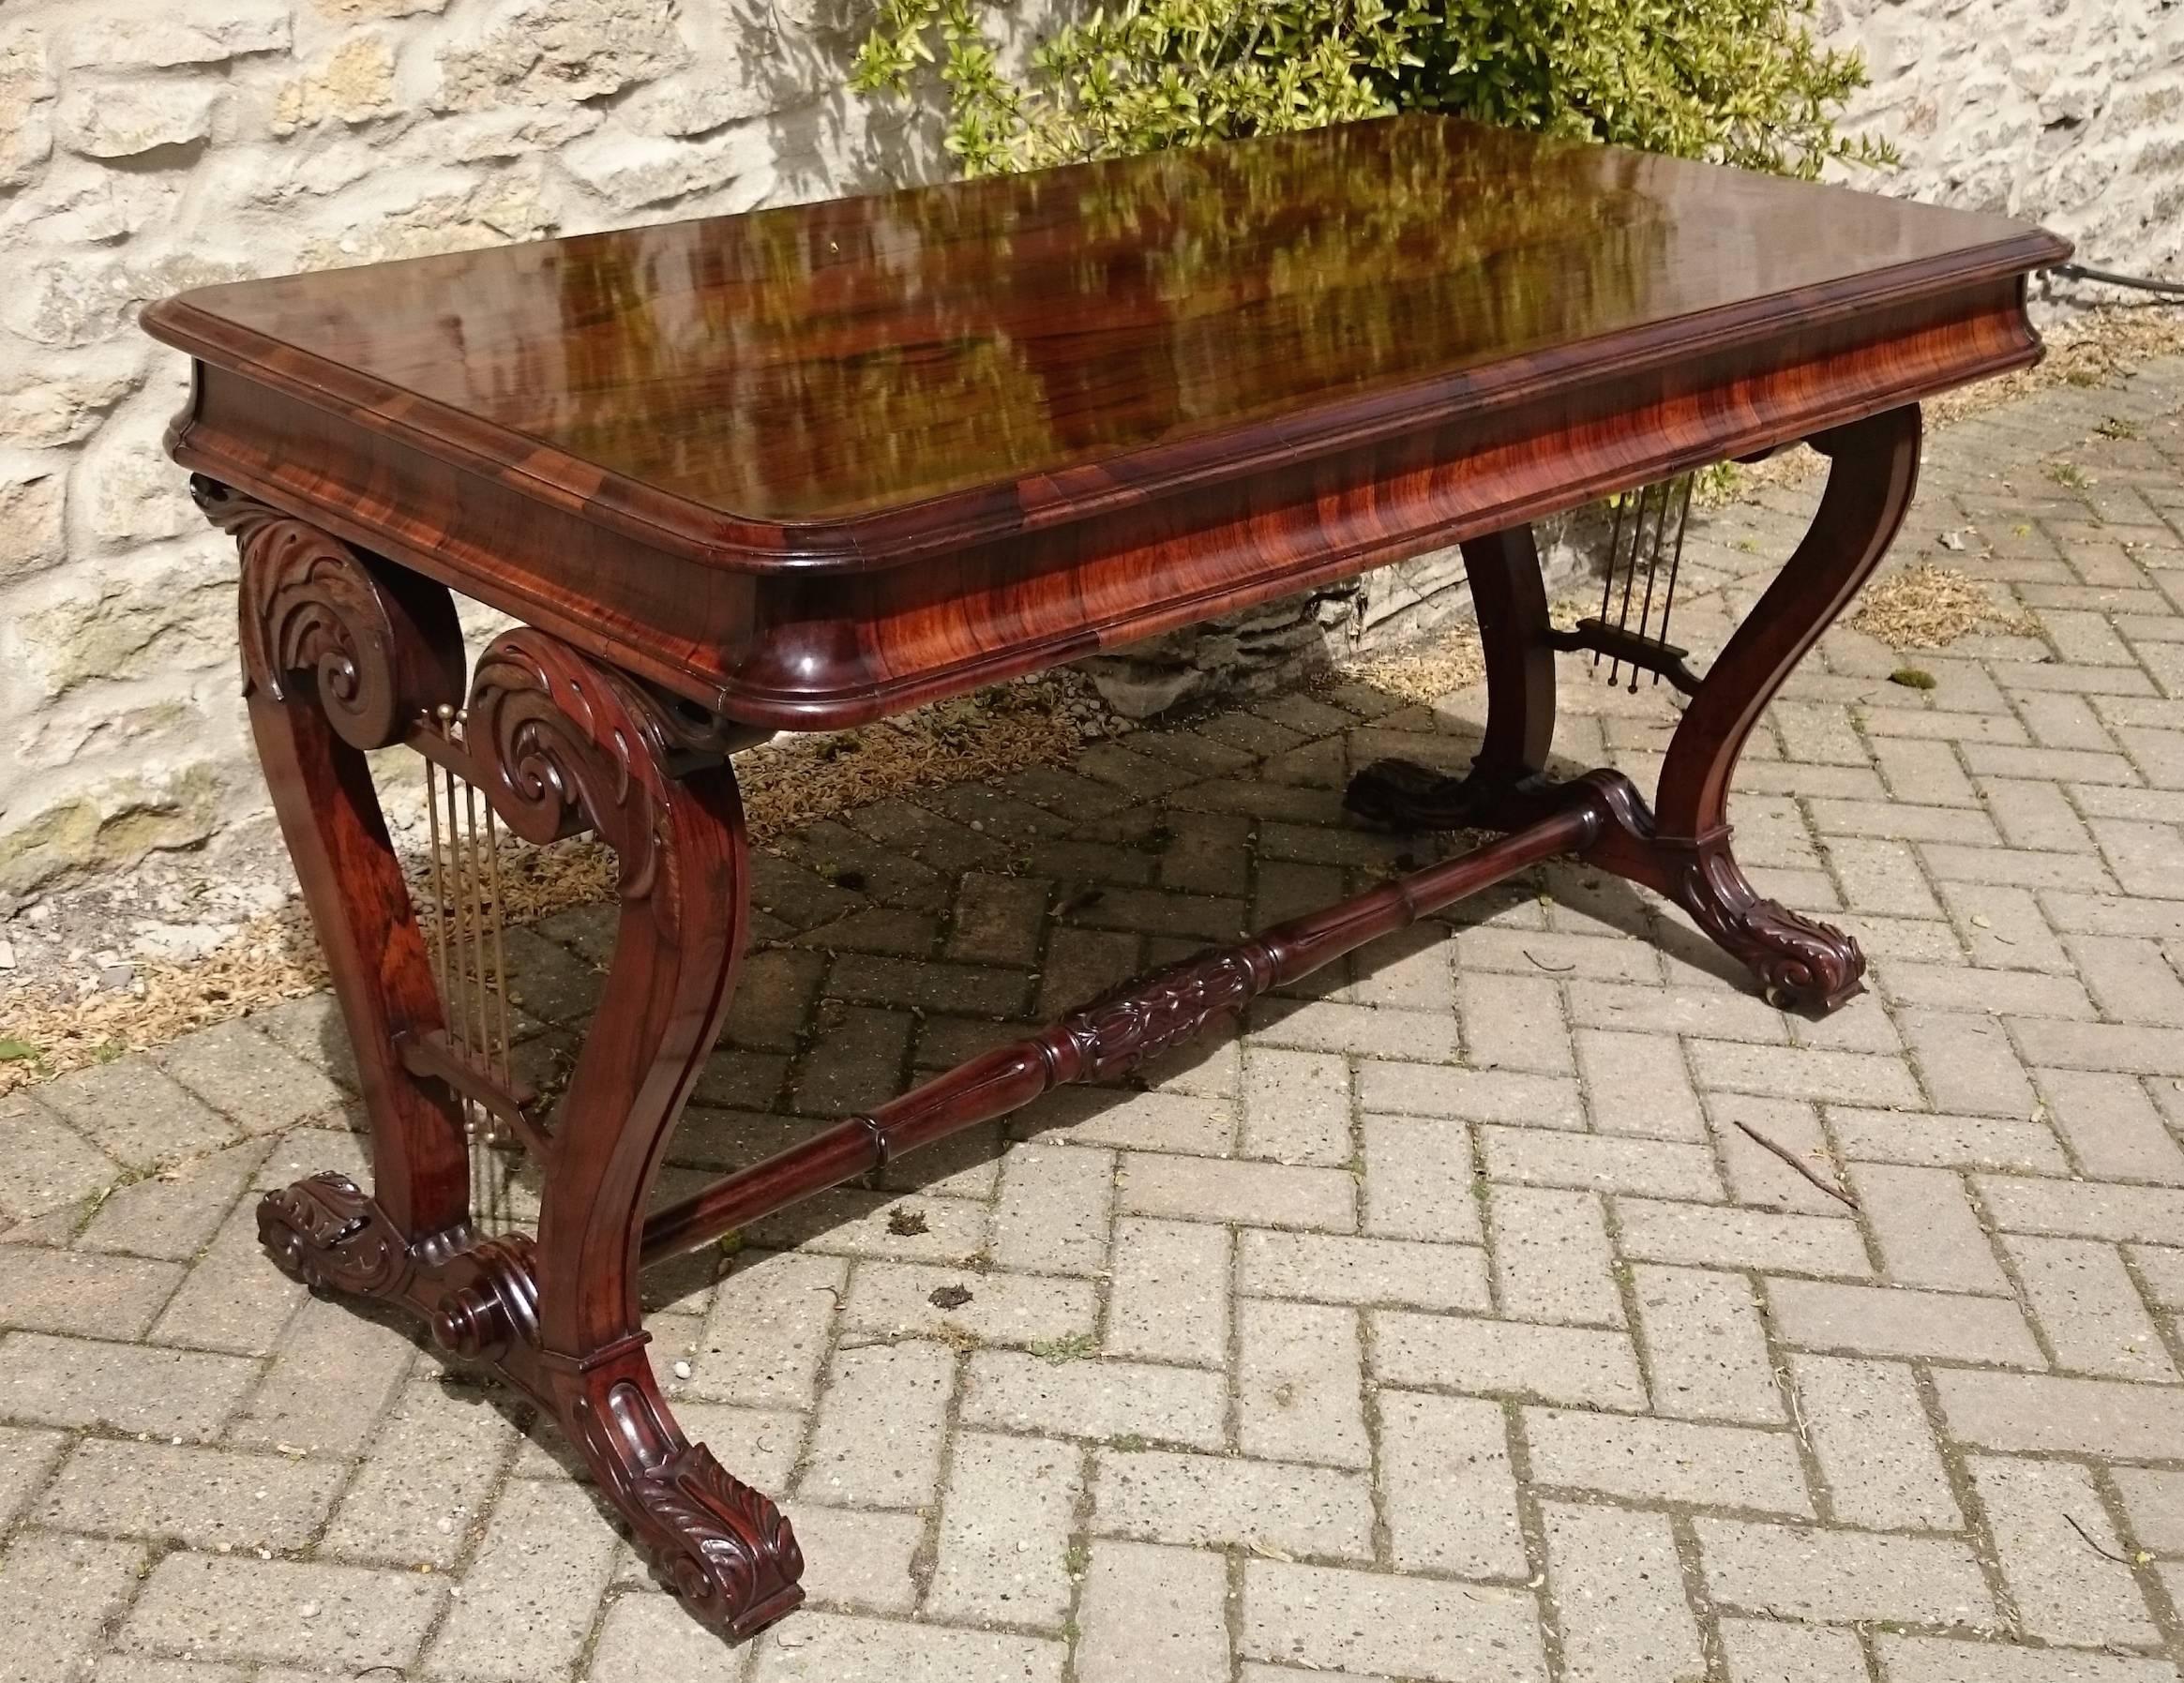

{"left": 199, "top": 485, "right": 804, "bottom": 1635}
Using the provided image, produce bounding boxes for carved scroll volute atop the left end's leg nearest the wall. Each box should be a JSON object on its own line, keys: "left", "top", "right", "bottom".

{"left": 190, "top": 478, "right": 463, "bottom": 749}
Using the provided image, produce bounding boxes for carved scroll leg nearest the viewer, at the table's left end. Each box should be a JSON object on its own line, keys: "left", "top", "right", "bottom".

{"left": 467, "top": 631, "right": 804, "bottom": 1637}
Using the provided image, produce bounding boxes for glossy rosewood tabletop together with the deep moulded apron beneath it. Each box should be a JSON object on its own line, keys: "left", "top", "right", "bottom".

{"left": 144, "top": 118, "right": 2069, "bottom": 729}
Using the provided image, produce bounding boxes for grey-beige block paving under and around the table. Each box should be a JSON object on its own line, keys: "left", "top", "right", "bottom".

{"left": 12, "top": 362, "right": 2184, "bottom": 1683}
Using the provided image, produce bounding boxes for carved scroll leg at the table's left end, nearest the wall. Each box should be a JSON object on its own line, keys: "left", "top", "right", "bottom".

{"left": 210, "top": 480, "right": 470, "bottom": 1257}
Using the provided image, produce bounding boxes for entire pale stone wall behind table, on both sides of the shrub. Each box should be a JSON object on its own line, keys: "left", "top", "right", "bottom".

{"left": 0, "top": 0, "right": 2184, "bottom": 894}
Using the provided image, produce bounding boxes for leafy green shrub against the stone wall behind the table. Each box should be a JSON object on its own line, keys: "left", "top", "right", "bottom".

{"left": 856, "top": 0, "right": 1891, "bottom": 177}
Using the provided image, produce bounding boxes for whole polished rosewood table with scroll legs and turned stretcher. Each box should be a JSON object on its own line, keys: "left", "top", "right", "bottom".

{"left": 144, "top": 118, "right": 2069, "bottom": 1635}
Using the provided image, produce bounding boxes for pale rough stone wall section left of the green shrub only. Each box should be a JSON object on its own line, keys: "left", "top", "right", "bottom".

{"left": 0, "top": 0, "right": 983, "bottom": 914}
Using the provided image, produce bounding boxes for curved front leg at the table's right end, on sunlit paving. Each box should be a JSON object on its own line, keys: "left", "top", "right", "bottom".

{"left": 1642, "top": 406, "right": 1920, "bottom": 1011}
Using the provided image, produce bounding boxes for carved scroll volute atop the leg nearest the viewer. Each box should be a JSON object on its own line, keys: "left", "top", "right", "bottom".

{"left": 467, "top": 631, "right": 707, "bottom": 914}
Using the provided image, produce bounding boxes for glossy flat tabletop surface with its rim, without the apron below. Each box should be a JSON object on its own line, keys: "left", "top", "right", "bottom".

{"left": 148, "top": 115, "right": 2064, "bottom": 565}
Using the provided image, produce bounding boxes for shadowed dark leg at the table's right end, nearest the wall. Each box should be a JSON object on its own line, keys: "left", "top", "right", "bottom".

{"left": 1343, "top": 526, "right": 1555, "bottom": 830}
